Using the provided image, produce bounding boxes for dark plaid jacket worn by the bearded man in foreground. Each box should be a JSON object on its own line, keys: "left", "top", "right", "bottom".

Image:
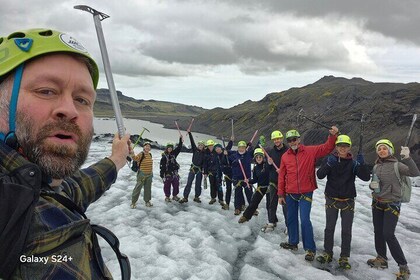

{"left": 0, "top": 144, "right": 117, "bottom": 280}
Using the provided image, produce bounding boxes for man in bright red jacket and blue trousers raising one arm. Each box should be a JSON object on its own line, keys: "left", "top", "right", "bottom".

{"left": 278, "top": 126, "right": 338, "bottom": 261}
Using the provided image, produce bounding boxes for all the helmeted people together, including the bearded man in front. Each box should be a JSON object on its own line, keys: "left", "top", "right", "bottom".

{"left": 0, "top": 26, "right": 420, "bottom": 279}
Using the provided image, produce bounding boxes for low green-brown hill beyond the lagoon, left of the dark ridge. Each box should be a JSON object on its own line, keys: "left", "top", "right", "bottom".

{"left": 94, "top": 89, "right": 206, "bottom": 126}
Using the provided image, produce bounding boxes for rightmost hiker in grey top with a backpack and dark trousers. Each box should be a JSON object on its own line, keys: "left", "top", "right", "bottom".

{"left": 367, "top": 139, "right": 420, "bottom": 280}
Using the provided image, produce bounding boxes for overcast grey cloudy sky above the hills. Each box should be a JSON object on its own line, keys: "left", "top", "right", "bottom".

{"left": 0, "top": 0, "right": 420, "bottom": 108}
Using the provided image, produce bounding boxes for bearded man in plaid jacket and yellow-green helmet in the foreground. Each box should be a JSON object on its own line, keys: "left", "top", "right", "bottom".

{"left": 0, "top": 29, "right": 131, "bottom": 279}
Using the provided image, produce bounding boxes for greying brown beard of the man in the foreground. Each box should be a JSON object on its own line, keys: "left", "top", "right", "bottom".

{"left": 16, "top": 113, "right": 93, "bottom": 179}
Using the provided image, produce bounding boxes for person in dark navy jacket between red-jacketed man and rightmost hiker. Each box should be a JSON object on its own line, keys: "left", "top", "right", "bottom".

{"left": 316, "top": 134, "right": 370, "bottom": 269}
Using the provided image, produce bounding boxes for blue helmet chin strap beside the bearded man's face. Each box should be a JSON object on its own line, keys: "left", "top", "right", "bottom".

{"left": 0, "top": 63, "right": 24, "bottom": 149}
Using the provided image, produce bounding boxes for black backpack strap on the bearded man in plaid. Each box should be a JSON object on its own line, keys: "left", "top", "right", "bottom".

{"left": 41, "top": 190, "right": 131, "bottom": 280}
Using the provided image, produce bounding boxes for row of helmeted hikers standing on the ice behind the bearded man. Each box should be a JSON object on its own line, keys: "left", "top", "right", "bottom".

{"left": 132, "top": 126, "right": 420, "bottom": 279}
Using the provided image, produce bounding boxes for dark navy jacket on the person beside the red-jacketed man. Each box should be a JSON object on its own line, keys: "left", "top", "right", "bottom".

{"left": 316, "top": 152, "right": 370, "bottom": 198}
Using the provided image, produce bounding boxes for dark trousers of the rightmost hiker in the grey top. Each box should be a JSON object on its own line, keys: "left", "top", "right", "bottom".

{"left": 372, "top": 201, "right": 407, "bottom": 266}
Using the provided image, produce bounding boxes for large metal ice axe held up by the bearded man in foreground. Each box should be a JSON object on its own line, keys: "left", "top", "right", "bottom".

{"left": 74, "top": 5, "right": 124, "bottom": 138}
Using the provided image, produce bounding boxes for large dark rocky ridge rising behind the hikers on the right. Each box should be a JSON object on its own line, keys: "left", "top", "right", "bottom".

{"left": 194, "top": 76, "right": 420, "bottom": 164}
